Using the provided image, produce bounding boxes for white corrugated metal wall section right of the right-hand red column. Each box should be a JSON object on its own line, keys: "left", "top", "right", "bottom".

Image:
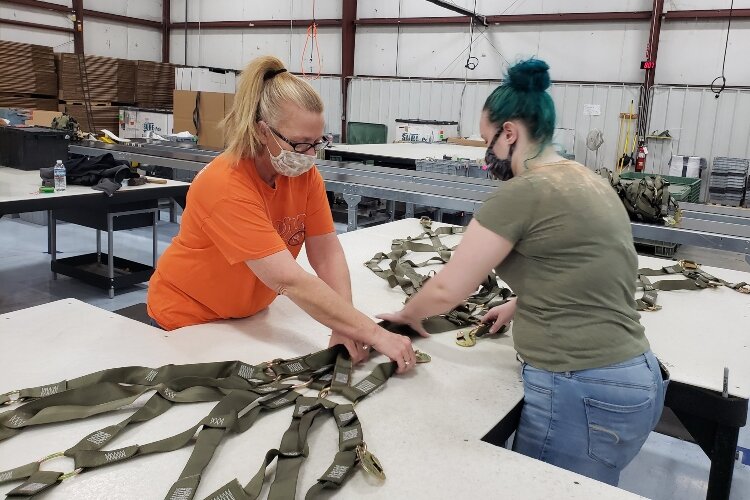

{"left": 646, "top": 85, "right": 750, "bottom": 199}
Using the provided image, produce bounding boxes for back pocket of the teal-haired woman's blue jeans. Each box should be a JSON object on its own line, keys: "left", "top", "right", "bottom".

{"left": 583, "top": 398, "right": 654, "bottom": 469}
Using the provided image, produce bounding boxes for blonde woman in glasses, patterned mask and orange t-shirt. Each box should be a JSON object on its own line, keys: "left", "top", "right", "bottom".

{"left": 148, "top": 56, "right": 416, "bottom": 372}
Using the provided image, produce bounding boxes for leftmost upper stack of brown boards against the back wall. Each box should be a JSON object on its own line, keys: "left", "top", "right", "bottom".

{"left": 0, "top": 41, "right": 57, "bottom": 109}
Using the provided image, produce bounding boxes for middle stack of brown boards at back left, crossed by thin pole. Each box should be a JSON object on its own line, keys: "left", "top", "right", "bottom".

{"left": 57, "top": 54, "right": 136, "bottom": 105}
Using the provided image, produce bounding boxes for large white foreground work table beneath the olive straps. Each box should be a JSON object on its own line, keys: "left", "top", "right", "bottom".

{"left": 0, "top": 219, "right": 648, "bottom": 500}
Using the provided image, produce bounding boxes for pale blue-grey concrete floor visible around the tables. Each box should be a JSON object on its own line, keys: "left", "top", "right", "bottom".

{"left": 0, "top": 214, "right": 750, "bottom": 500}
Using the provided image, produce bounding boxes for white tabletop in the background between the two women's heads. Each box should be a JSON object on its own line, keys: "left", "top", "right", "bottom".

{"left": 326, "top": 142, "right": 487, "bottom": 160}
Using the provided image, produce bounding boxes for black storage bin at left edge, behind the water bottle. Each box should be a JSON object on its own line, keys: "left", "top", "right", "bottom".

{"left": 0, "top": 127, "right": 70, "bottom": 170}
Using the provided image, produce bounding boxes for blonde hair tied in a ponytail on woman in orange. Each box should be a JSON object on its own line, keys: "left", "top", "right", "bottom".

{"left": 222, "top": 56, "right": 323, "bottom": 159}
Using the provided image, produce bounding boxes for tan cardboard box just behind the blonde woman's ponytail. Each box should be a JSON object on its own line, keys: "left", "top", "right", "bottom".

{"left": 173, "top": 90, "right": 234, "bottom": 149}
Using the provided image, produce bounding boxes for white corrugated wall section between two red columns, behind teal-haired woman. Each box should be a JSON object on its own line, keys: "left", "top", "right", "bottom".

{"left": 347, "top": 77, "right": 641, "bottom": 168}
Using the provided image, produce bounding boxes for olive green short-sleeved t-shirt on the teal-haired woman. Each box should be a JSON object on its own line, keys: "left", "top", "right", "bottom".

{"left": 475, "top": 161, "right": 649, "bottom": 372}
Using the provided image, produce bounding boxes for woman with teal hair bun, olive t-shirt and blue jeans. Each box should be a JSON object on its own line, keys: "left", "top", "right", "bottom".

{"left": 382, "top": 59, "right": 666, "bottom": 485}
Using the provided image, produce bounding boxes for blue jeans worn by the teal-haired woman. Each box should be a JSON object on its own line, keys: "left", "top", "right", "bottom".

{"left": 513, "top": 351, "right": 668, "bottom": 486}
